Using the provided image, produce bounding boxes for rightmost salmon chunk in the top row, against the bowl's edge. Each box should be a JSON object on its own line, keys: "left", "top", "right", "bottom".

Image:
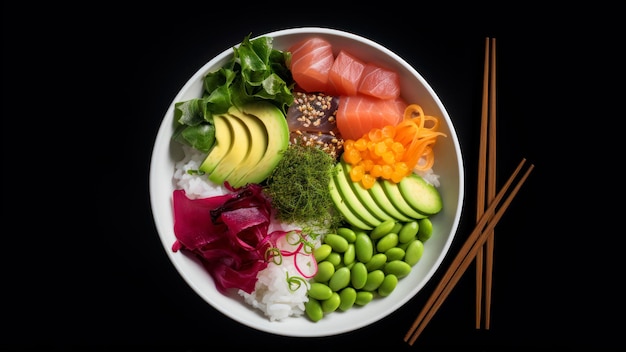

{"left": 358, "top": 63, "right": 400, "bottom": 99}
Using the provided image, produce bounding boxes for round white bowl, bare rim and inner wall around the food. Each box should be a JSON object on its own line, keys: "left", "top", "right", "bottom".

{"left": 150, "top": 27, "right": 464, "bottom": 337}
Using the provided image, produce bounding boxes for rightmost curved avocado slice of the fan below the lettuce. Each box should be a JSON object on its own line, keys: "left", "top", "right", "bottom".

{"left": 236, "top": 101, "right": 289, "bottom": 183}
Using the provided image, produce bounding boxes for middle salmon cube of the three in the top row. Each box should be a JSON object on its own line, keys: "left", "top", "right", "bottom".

{"left": 327, "top": 50, "right": 365, "bottom": 96}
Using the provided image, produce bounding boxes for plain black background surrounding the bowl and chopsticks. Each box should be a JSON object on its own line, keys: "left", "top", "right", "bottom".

{"left": 0, "top": 2, "right": 624, "bottom": 351}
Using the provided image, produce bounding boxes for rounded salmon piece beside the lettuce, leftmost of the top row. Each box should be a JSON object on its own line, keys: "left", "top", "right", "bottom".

{"left": 288, "top": 37, "right": 335, "bottom": 93}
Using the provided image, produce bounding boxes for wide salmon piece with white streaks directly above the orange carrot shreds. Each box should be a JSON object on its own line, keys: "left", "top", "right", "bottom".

{"left": 337, "top": 95, "right": 408, "bottom": 140}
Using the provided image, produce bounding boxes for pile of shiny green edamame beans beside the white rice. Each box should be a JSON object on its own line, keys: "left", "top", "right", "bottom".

{"left": 305, "top": 218, "right": 432, "bottom": 322}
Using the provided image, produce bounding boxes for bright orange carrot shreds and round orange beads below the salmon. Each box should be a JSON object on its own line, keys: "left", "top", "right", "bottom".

{"left": 343, "top": 104, "right": 446, "bottom": 189}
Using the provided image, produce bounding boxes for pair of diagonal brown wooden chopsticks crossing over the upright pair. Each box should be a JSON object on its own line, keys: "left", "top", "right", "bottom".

{"left": 404, "top": 159, "right": 534, "bottom": 345}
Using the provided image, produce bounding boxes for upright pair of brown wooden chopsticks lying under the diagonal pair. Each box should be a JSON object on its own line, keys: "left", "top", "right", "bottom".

{"left": 476, "top": 38, "right": 496, "bottom": 329}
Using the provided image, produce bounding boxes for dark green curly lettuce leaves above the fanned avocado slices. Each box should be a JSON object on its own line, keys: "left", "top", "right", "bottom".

{"left": 172, "top": 34, "right": 295, "bottom": 153}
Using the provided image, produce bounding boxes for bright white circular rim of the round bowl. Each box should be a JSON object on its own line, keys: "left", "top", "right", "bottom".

{"left": 149, "top": 27, "right": 465, "bottom": 337}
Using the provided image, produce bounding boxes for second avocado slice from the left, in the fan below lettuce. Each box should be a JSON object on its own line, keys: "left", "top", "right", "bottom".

{"left": 209, "top": 114, "right": 251, "bottom": 185}
